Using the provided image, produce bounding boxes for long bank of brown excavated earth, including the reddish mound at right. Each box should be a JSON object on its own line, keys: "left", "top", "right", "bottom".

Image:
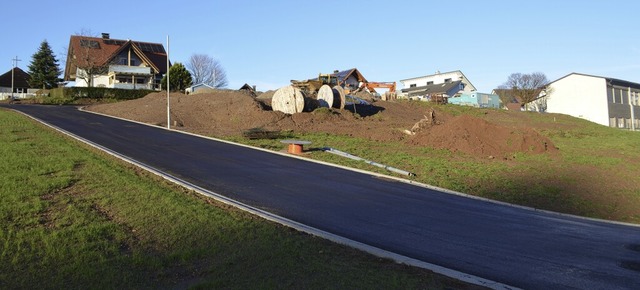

{"left": 85, "top": 90, "right": 557, "bottom": 158}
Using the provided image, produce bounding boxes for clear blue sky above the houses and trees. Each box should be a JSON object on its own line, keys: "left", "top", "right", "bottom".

{"left": 0, "top": 0, "right": 640, "bottom": 92}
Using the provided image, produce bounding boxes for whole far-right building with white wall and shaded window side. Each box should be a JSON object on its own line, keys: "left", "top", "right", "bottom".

{"left": 545, "top": 73, "right": 640, "bottom": 130}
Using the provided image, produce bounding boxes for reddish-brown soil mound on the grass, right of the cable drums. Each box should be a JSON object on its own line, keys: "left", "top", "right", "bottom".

{"left": 409, "top": 115, "right": 557, "bottom": 157}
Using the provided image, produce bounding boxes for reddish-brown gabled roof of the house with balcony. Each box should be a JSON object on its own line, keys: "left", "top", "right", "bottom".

{"left": 64, "top": 35, "right": 167, "bottom": 80}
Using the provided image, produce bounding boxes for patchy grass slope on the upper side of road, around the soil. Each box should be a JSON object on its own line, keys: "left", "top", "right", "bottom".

{"left": 231, "top": 103, "right": 640, "bottom": 223}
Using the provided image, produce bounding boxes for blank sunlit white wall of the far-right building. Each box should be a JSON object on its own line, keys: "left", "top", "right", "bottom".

{"left": 547, "top": 74, "right": 609, "bottom": 126}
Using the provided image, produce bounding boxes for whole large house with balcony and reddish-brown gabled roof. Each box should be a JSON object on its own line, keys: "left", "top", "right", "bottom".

{"left": 64, "top": 33, "right": 167, "bottom": 90}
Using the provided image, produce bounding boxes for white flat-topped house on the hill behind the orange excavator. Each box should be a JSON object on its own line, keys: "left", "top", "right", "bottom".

{"left": 400, "top": 70, "right": 476, "bottom": 98}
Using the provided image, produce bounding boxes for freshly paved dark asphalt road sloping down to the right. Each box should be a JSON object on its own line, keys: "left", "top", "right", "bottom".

{"left": 5, "top": 105, "right": 640, "bottom": 289}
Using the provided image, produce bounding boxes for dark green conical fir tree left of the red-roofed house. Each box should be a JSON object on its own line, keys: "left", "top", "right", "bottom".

{"left": 29, "top": 40, "right": 61, "bottom": 89}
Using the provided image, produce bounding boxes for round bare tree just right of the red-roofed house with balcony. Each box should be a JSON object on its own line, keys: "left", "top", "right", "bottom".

{"left": 187, "top": 54, "right": 228, "bottom": 88}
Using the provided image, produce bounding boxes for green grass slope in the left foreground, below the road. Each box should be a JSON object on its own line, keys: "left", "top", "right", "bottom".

{"left": 0, "top": 109, "right": 480, "bottom": 289}
